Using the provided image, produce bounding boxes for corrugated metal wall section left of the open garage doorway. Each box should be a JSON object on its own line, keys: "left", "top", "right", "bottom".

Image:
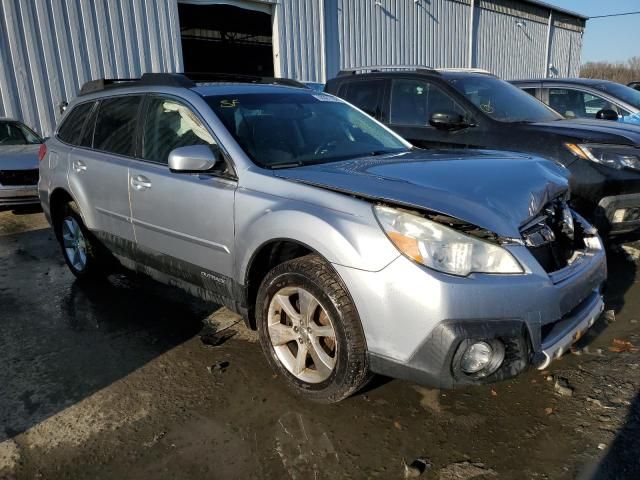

{"left": 0, "top": 0, "right": 182, "bottom": 135}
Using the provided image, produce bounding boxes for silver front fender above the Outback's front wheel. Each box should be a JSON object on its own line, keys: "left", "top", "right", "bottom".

{"left": 235, "top": 190, "right": 400, "bottom": 279}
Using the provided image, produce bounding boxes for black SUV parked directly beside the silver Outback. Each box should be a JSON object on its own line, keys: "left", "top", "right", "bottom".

{"left": 325, "top": 67, "right": 640, "bottom": 235}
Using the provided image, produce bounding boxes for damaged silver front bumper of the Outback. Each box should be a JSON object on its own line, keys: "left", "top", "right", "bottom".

{"left": 335, "top": 232, "right": 606, "bottom": 388}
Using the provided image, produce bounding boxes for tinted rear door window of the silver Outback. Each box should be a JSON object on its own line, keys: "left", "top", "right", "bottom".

{"left": 93, "top": 96, "right": 142, "bottom": 156}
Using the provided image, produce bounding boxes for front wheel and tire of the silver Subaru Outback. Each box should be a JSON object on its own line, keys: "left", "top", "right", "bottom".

{"left": 256, "top": 255, "right": 369, "bottom": 403}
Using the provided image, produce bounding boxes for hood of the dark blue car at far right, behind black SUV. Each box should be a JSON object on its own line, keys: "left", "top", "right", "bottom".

{"left": 526, "top": 119, "right": 640, "bottom": 146}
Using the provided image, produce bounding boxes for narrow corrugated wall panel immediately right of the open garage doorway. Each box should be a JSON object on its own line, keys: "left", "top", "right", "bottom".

{"left": 273, "top": 0, "right": 325, "bottom": 82}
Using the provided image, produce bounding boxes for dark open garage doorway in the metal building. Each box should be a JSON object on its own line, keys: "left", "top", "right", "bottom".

{"left": 178, "top": 2, "right": 273, "bottom": 77}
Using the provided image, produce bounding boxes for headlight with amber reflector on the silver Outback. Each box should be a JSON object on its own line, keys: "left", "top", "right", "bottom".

{"left": 374, "top": 205, "right": 524, "bottom": 277}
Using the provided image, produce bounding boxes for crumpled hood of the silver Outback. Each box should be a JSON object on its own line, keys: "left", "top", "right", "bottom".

{"left": 275, "top": 150, "right": 568, "bottom": 238}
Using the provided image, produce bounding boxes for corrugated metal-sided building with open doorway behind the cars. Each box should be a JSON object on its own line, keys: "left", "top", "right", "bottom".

{"left": 0, "top": 0, "right": 587, "bottom": 135}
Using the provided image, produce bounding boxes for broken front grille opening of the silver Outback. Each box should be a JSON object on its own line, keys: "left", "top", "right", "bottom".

{"left": 522, "top": 199, "right": 585, "bottom": 273}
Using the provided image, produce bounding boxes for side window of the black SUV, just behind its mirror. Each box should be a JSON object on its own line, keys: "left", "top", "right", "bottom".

{"left": 389, "top": 79, "right": 466, "bottom": 127}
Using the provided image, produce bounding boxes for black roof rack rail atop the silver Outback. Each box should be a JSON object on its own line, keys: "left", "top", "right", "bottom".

{"left": 79, "top": 72, "right": 309, "bottom": 95}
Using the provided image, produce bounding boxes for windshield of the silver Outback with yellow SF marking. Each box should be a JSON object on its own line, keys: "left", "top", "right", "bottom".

{"left": 207, "top": 92, "right": 410, "bottom": 167}
